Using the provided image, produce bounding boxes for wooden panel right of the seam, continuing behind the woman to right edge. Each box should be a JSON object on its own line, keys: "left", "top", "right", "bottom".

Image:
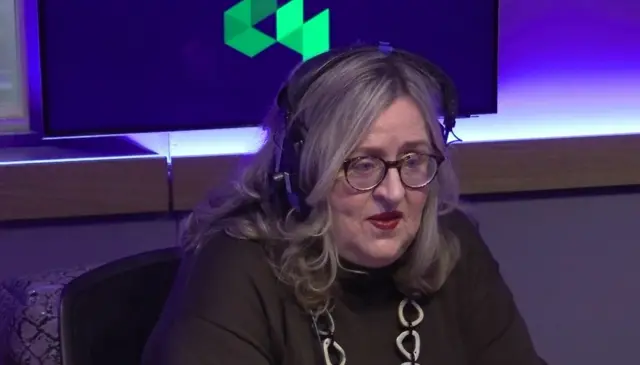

{"left": 173, "top": 135, "right": 640, "bottom": 210}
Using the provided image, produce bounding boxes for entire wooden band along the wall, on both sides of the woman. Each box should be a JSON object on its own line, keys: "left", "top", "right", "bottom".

{"left": 0, "top": 135, "right": 640, "bottom": 220}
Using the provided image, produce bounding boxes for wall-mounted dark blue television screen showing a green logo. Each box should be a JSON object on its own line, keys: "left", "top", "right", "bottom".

{"left": 39, "top": 0, "right": 498, "bottom": 136}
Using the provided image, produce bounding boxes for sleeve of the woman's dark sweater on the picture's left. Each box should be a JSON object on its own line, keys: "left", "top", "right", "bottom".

{"left": 143, "top": 236, "right": 280, "bottom": 365}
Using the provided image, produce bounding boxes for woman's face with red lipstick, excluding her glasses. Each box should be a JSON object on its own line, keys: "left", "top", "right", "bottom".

{"left": 329, "top": 98, "right": 431, "bottom": 268}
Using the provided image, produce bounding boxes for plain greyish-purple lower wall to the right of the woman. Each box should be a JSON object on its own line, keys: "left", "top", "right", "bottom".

{"left": 476, "top": 194, "right": 640, "bottom": 365}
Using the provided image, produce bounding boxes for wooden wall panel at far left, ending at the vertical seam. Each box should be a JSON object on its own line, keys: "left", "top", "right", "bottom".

{"left": 0, "top": 157, "right": 169, "bottom": 220}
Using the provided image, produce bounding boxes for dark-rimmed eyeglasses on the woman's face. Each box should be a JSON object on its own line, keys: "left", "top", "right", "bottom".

{"left": 342, "top": 153, "right": 444, "bottom": 191}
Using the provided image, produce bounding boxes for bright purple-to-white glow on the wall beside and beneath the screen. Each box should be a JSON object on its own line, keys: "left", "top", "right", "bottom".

{"left": 141, "top": 0, "right": 640, "bottom": 156}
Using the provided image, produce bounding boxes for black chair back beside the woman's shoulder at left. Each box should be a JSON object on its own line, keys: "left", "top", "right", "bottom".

{"left": 59, "top": 247, "right": 182, "bottom": 365}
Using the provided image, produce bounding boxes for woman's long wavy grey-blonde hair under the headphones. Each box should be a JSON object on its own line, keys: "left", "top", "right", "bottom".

{"left": 181, "top": 47, "right": 460, "bottom": 313}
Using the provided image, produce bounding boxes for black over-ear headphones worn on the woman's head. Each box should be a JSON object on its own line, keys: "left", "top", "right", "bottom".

{"left": 271, "top": 42, "right": 459, "bottom": 221}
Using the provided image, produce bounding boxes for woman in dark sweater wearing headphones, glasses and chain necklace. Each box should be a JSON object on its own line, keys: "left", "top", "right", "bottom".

{"left": 144, "top": 47, "right": 543, "bottom": 365}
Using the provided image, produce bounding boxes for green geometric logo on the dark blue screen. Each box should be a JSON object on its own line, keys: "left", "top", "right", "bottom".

{"left": 224, "top": 0, "right": 330, "bottom": 60}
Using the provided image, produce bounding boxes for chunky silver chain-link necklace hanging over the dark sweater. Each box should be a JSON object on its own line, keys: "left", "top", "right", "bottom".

{"left": 312, "top": 298, "right": 424, "bottom": 365}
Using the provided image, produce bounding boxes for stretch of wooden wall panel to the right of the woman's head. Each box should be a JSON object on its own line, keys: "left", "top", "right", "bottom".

{"left": 452, "top": 135, "right": 640, "bottom": 194}
